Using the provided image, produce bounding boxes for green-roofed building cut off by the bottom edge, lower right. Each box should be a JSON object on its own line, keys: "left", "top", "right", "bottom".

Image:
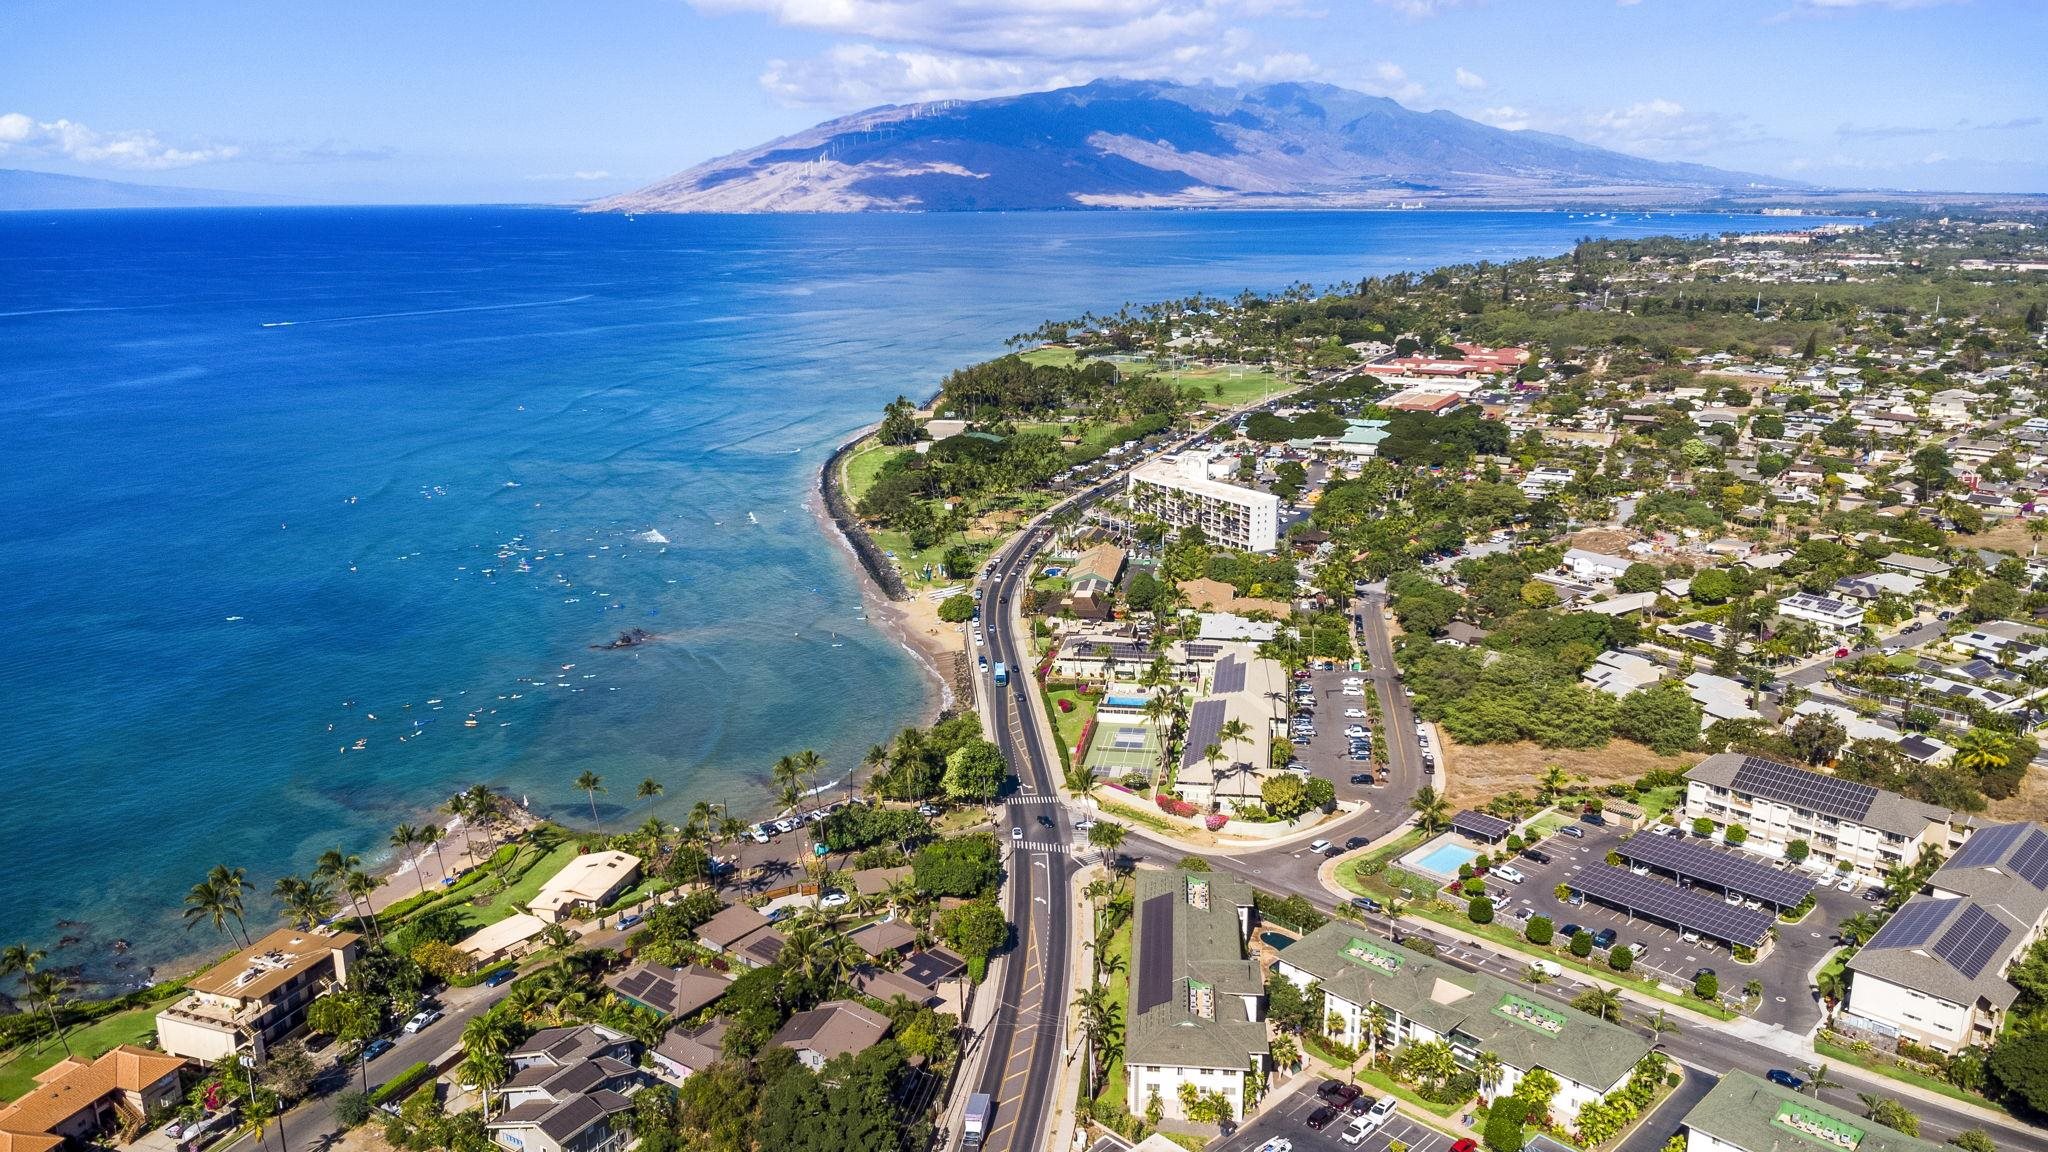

{"left": 1683, "top": 1068, "right": 1944, "bottom": 1152}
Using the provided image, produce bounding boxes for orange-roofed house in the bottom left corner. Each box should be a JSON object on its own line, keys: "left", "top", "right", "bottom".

{"left": 0, "top": 1043, "right": 184, "bottom": 1152}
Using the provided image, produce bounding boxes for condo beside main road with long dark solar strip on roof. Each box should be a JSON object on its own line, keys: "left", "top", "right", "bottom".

{"left": 1124, "top": 871, "right": 1272, "bottom": 1119}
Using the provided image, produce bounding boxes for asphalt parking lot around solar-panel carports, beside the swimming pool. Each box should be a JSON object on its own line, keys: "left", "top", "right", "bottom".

{"left": 1458, "top": 811, "right": 1868, "bottom": 1031}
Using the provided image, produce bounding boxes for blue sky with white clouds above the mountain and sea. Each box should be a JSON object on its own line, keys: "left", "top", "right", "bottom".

{"left": 0, "top": 0, "right": 2048, "bottom": 203}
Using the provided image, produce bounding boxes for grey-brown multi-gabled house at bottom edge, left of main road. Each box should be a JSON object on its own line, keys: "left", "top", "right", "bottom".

{"left": 483, "top": 1025, "right": 647, "bottom": 1152}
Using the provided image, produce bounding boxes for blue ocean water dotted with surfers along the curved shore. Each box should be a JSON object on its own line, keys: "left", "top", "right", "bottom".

{"left": 0, "top": 209, "right": 1826, "bottom": 978}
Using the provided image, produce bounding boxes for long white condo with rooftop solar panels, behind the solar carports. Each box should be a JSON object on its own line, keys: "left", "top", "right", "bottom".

{"left": 1686, "top": 752, "right": 1970, "bottom": 879}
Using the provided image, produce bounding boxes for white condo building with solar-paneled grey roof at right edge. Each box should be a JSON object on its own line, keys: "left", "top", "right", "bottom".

{"left": 1841, "top": 824, "right": 2048, "bottom": 1052}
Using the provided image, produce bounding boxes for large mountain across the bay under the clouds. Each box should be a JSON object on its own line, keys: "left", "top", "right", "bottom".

{"left": 588, "top": 80, "right": 1802, "bottom": 213}
